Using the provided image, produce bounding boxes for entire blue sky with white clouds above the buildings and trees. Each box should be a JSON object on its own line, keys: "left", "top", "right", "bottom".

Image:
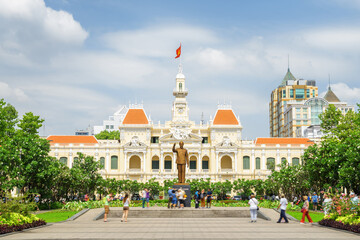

{"left": 0, "top": 0, "right": 360, "bottom": 139}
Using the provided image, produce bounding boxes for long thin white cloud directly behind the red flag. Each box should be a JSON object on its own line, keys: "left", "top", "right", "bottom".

{"left": 103, "top": 25, "right": 218, "bottom": 58}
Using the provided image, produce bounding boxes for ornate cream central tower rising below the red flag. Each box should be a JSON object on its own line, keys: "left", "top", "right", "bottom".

{"left": 172, "top": 64, "right": 189, "bottom": 122}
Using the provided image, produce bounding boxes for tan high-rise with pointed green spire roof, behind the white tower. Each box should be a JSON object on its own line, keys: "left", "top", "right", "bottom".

{"left": 269, "top": 68, "right": 318, "bottom": 137}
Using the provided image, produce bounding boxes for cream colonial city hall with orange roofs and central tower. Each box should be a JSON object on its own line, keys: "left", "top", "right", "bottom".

{"left": 47, "top": 67, "right": 312, "bottom": 182}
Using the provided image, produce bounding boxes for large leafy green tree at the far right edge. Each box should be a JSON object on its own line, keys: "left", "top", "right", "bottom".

{"left": 304, "top": 105, "right": 360, "bottom": 192}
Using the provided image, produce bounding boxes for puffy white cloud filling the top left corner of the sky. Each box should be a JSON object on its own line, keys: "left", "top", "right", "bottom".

{"left": 0, "top": 0, "right": 88, "bottom": 61}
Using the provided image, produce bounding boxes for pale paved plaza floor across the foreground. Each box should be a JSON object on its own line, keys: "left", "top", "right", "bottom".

{"left": 3, "top": 209, "right": 360, "bottom": 240}
